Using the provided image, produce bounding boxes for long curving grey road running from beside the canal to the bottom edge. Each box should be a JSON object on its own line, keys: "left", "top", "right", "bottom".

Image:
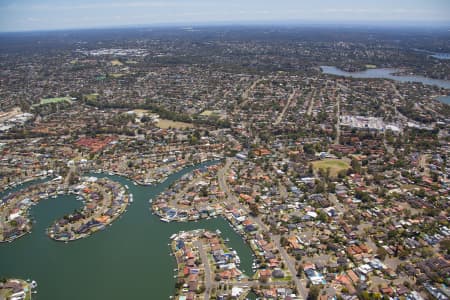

{"left": 217, "top": 158, "right": 307, "bottom": 299}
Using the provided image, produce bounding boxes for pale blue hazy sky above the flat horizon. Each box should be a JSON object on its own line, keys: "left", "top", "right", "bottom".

{"left": 0, "top": 0, "right": 450, "bottom": 32}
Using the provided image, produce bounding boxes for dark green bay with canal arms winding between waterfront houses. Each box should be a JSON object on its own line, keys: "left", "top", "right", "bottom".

{"left": 0, "top": 167, "right": 252, "bottom": 300}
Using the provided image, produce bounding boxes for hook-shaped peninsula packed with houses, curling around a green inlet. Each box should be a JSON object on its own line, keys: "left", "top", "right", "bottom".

{"left": 0, "top": 177, "right": 129, "bottom": 242}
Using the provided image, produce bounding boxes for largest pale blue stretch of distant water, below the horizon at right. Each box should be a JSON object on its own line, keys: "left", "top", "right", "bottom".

{"left": 320, "top": 66, "right": 450, "bottom": 89}
